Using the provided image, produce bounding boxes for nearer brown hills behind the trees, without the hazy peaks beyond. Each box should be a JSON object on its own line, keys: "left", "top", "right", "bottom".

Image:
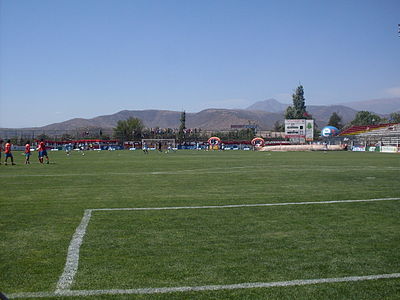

{"left": 0, "top": 106, "right": 356, "bottom": 136}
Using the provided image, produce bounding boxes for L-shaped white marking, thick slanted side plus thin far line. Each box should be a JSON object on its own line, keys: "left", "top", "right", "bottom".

{"left": 56, "top": 198, "right": 400, "bottom": 293}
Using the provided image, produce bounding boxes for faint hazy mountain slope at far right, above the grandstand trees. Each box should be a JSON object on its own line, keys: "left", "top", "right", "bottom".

{"left": 340, "top": 97, "right": 400, "bottom": 114}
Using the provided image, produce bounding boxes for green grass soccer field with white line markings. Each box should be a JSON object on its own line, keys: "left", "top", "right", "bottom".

{"left": 0, "top": 150, "right": 400, "bottom": 299}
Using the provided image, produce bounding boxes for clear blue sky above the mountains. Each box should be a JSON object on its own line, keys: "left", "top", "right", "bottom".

{"left": 0, "top": 0, "right": 400, "bottom": 127}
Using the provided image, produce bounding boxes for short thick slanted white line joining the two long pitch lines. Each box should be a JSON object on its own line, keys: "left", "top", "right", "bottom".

{"left": 56, "top": 209, "right": 92, "bottom": 291}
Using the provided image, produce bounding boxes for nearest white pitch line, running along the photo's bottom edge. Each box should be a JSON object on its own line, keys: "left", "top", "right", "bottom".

{"left": 8, "top": 273, "right": 400, "bottom": 299}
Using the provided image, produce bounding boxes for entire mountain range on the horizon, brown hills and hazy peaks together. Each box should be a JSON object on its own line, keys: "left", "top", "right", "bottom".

{"left": 0, "top": 98, "right": 400, "bottom": 134}
